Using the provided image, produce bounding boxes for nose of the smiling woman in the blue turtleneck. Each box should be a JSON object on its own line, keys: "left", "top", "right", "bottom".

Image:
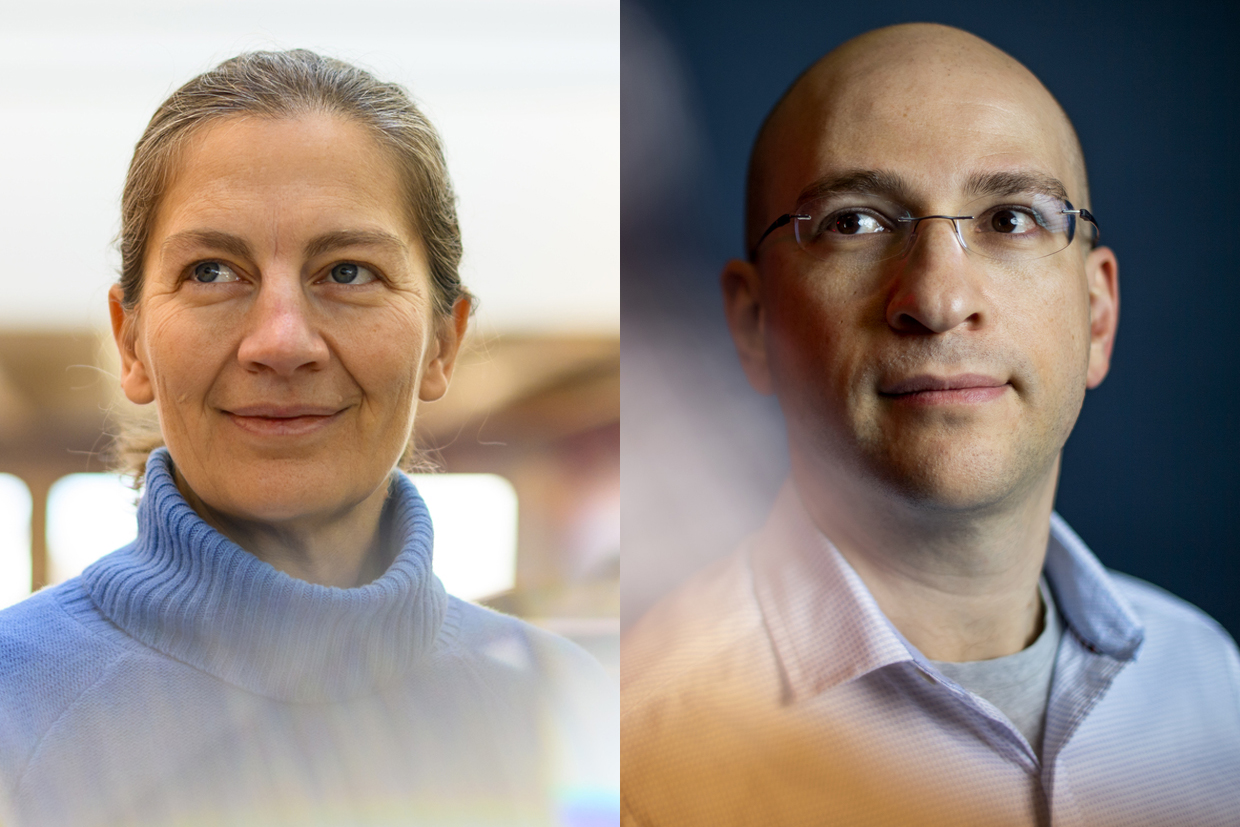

{"left": 237, "top": 272, "right": 330, "bottom": 377}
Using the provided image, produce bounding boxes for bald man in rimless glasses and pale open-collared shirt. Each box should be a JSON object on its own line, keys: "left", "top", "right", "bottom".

{"left": 622, "top": 25, "right": 1240, "bottom": 826}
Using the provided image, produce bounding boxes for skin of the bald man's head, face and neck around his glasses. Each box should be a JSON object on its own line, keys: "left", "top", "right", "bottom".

{"left": 722, "top": 25, "right": 1118, "bottom": 661}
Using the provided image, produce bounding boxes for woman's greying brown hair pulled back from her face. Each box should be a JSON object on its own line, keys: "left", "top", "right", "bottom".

{"left": 115, "top": 48, "right": 472, "bottom": 486}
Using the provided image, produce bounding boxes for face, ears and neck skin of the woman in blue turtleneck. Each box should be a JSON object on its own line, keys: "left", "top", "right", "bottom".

{"left": 109, "top": 114, "right": 469, "bottom": 588}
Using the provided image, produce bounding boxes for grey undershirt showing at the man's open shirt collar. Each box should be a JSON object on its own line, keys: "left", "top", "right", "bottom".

{"left": 930, "top": 579, "right": 1064, "bottom": 759}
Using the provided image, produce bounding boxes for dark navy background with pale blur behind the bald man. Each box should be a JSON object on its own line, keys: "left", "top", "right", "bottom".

{"left": 621, "top": 0, "right": 1240, "bottom": 637}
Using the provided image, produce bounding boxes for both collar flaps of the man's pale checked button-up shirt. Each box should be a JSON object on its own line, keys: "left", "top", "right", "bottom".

{"left": 751, "top": 481, "right": 1143, "bottom": 703}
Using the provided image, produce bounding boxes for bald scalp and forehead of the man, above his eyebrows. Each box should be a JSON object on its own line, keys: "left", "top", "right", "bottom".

{"left": 745, "top": 24, "right": 1089, "bottom": 249}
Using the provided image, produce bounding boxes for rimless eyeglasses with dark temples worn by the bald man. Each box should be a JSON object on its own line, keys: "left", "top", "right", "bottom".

{"left": 749, "top": 192, "right": 1099, "bottom": 264}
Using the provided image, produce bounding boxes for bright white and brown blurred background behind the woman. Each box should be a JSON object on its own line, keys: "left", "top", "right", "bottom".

{"left": 0, "top": 0, "right": 620, "bottom": 671}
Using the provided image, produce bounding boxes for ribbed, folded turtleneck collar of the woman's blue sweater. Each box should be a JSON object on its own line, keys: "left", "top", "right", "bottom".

{"left": 83, "top": 449, "right": 448, "bottom": 702}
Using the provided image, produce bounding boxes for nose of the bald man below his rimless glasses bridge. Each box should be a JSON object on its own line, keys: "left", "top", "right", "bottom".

{"left": 887, "top": 217, "right": 988, "bottom": 334}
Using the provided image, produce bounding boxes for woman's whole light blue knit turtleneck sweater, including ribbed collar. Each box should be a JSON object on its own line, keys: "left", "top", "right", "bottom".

{"left": 0, "top": 449, "right": 619, "bottom": 827}
